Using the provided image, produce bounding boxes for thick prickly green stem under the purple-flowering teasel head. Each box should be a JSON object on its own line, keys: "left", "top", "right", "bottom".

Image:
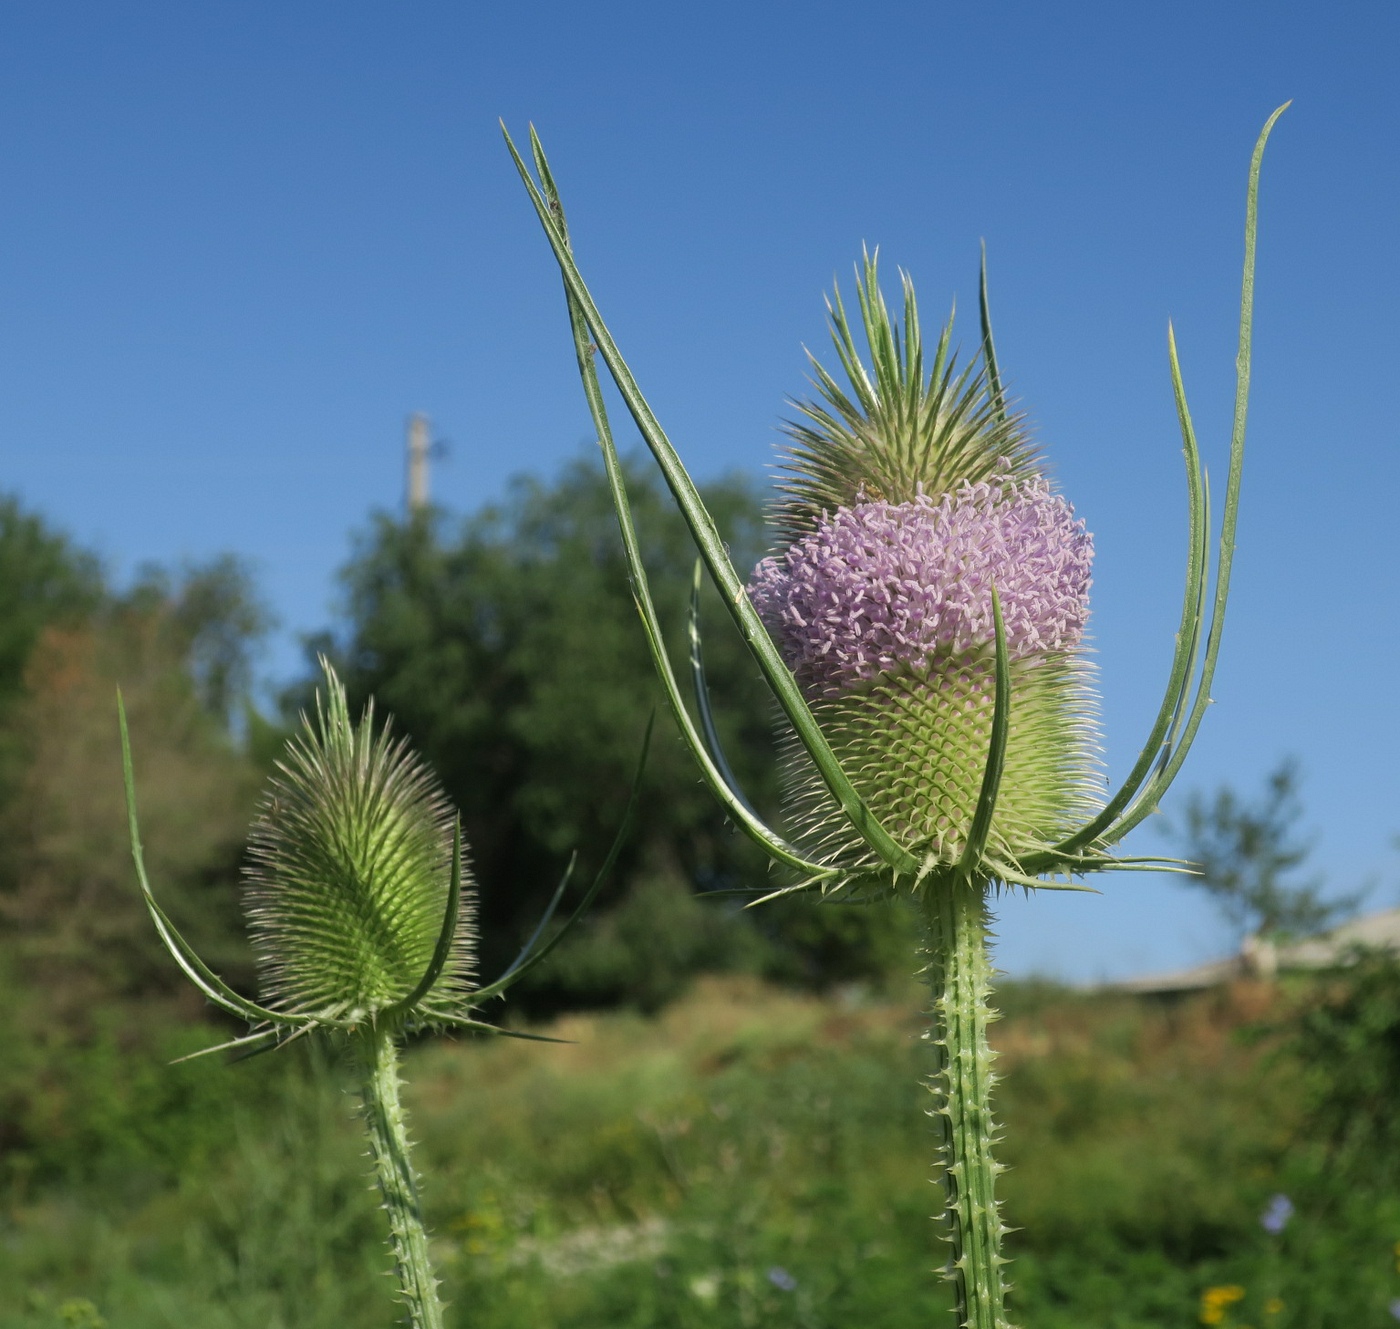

{"left": 923, "top": 874, "right": 1011, "bottom": 1329}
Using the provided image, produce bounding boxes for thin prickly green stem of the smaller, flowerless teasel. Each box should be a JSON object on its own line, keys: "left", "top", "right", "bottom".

{"left": 358, "top": 1025, "right": 442, "bottom": 1329}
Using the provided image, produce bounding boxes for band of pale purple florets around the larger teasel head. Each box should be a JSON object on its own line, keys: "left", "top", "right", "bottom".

{"left": 749, "top": 478, "right": 1093, "bottom": 695}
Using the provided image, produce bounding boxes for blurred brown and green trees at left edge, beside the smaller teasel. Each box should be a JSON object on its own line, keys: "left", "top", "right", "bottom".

{"left": 0, "top": 500, "right": 266, "bottom": 1031}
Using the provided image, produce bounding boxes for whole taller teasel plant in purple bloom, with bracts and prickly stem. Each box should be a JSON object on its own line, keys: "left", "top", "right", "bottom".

{"left": 503, "top": 104, "right": 1287, "bottom": 1329}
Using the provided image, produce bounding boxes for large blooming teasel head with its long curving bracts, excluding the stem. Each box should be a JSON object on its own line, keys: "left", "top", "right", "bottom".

{"left": 507, "top": 100, "right": 1284, "bottom": 892}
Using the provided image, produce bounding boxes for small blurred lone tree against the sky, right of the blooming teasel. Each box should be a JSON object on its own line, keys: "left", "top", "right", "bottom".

{"left": 1169, "top": 759, "right": 1361, "bottom": 938}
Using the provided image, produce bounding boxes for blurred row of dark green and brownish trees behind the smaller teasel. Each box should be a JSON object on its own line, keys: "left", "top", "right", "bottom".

{"left": 0, "top": 450, "right": 909, "bottom": 1081}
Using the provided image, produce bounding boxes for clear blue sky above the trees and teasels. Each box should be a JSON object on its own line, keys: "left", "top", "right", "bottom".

{"left": 0, "top": 0, "right": 1400, "bottom": 979}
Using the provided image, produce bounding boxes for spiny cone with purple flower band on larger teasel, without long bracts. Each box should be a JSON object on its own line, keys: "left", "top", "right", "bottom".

{"left": 749, "top": 258, "right": 1096, "bottom": 870}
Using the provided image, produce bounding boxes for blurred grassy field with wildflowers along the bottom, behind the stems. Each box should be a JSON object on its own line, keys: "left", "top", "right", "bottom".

{"left": 0, "top": 979, "right": 1400, "bottom": 1329}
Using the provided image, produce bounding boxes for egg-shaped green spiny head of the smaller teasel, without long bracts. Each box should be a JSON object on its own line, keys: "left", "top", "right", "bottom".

{"left": 245, "top": 660, "right": 475, "bottom": 1021}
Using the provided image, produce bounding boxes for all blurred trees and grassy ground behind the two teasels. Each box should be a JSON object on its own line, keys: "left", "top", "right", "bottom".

{"left": 0, "top": 462, "right": 1400, "bottom": 1329}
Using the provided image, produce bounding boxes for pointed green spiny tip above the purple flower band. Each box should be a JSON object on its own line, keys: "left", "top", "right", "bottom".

{"left": 771, "top": 251, "right": 1039, "bottom": 543}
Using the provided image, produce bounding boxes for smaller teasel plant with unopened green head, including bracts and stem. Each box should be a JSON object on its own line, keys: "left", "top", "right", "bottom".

{"left": 118, "top": 657, "right": 651, "bottom": 1329}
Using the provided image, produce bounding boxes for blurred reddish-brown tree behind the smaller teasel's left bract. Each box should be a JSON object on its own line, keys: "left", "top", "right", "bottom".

{"left": 0, "top": 554, "right": 266, "bottom": 1027}
